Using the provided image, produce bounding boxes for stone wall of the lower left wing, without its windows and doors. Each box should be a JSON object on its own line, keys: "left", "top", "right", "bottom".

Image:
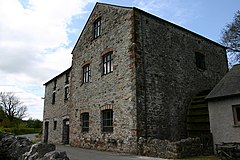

{"left": 43, "top": 69, "right": 70, "bottom": 144}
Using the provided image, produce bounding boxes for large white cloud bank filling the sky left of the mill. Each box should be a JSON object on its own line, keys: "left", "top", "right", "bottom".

{"left": 0, "top": 0, "right": 95, "bottom": 119}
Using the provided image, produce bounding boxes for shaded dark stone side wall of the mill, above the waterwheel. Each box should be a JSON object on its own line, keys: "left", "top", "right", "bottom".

{"left": 135, "top": 9, "right": 227, "bottom": 141}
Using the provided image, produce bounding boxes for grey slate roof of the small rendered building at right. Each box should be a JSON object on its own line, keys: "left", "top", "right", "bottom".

{"left": 206, "top": 64, "right": 240, "bottom": 100}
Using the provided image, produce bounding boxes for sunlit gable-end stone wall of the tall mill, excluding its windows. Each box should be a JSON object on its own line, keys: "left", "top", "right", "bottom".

{"left": 70, "top": 4, "right": 136, "bottom": 152}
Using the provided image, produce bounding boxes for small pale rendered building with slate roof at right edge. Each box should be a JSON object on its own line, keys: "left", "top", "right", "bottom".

{"left": 206, "top": 64, "right": 240, "bottom": 149}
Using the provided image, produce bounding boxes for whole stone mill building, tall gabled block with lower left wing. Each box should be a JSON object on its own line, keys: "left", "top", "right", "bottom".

{"left": 43, "top": 3, "right": 228, "bottom": 158}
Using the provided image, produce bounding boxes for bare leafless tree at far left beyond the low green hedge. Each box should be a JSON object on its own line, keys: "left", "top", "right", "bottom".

{"left": 0, "top": 92, "right": 27, "bottom": 121}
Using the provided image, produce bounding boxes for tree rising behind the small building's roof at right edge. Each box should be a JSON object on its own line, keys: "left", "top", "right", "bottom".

{"left": 221, "top": 10, "right": 240, "bottom": 65}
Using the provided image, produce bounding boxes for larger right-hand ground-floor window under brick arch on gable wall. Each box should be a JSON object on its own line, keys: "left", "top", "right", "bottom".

{"left": 102, "top": 109, "right": 113, "bottom": 132}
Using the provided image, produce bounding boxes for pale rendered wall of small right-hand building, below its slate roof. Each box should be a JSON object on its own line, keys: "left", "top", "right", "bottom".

{"left": 208, "top": 96, "right": 240, "bottom": 147}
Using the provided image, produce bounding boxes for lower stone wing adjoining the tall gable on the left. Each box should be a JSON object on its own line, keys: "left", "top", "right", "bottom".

{"left": 43, "top": 68, "right": 71, "bottom": 144}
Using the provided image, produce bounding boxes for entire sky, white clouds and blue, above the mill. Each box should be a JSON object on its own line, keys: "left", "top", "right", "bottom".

{"left": 0, "top": 0, "right": 240, "bottom": 120}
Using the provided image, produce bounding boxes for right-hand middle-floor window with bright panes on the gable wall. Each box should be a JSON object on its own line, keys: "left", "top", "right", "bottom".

{"left": 102, "top": 52, "right": 113, "bottom": 75}
